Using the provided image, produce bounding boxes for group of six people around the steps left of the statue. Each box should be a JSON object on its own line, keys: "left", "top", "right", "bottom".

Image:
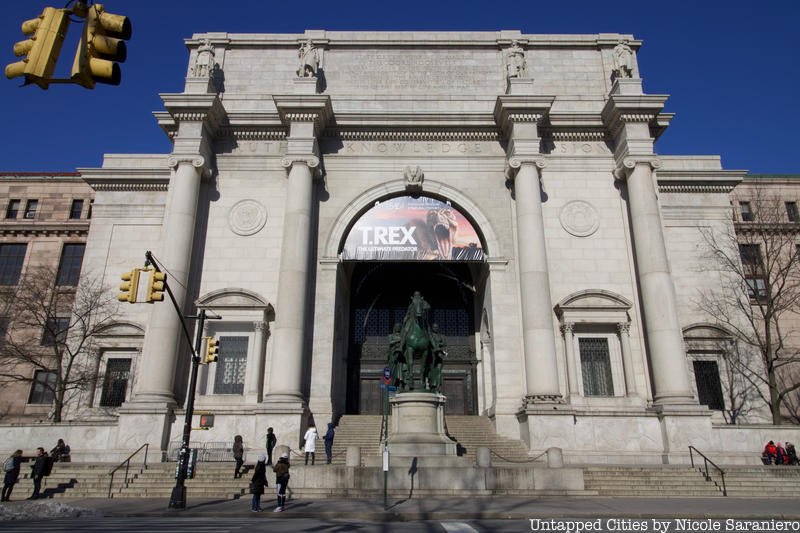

{"left": 238, "top": 422, "right": 335, "bottom": 513}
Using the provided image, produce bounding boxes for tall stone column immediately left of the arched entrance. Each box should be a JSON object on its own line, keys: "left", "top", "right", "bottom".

{"left": 267, "top": 156, "right": 319, "bottom": 403}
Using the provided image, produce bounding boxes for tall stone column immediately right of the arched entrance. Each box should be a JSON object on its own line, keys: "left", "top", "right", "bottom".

{"left": 509, "top": 158, "right": 561, "bottom": 403}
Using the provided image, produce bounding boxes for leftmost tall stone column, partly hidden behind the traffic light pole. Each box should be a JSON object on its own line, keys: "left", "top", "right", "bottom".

{"left": 133, "top": 155, "right": 207, "bottom": 404}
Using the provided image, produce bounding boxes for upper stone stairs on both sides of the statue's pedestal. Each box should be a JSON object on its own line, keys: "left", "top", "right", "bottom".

{"left": 328, "top": 415, "right": 532, "bottom": 465}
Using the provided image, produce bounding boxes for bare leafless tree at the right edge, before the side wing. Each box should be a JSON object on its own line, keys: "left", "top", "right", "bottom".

{"left": 698, "top": 185, "right": 800, "bottom": 424}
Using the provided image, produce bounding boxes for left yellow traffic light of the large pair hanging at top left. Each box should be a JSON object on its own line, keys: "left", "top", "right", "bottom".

{"left": 6, "top": 7, "right": 69, "bottom": 89}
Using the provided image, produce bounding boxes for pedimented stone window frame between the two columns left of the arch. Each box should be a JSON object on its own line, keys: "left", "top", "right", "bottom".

{"left": 195, "top": 287, "right": 275, "bottom": 407}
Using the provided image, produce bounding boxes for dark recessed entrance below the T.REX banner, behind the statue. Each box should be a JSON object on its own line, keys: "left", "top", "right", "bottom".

{"left": 347, "top": 261, "right": 477, "bottom": 414}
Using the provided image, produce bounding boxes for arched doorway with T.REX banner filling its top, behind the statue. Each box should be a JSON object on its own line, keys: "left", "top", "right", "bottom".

{"left": 342, "top": 196, "right": 487, "bottom": 414}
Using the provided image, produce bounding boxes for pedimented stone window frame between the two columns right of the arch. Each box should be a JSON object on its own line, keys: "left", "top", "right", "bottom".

{"left": 555, "top": 289, "right": 641, "bottom": 403}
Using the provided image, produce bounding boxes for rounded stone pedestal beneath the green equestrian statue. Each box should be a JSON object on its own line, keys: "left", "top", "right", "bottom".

{"left": 389, "top": 392, "right": 456, "bottom": 457}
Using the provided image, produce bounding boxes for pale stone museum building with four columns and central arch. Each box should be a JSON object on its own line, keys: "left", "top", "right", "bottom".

{"left": 4, "top": 30, "right": 789, "bottom": 463}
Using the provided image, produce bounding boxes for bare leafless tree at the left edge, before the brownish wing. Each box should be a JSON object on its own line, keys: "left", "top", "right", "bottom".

{"left": 0, "top": 267, "right": 116, "bottom": 422}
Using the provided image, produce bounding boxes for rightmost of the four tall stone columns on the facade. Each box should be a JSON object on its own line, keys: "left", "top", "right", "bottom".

{"left": 617, "top": 157, "right": 694, "bottom": 404}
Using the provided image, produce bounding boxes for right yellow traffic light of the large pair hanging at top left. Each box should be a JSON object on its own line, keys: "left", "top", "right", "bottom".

{"left": 72, "top": 4, "right": 131, "bottom": 89}
